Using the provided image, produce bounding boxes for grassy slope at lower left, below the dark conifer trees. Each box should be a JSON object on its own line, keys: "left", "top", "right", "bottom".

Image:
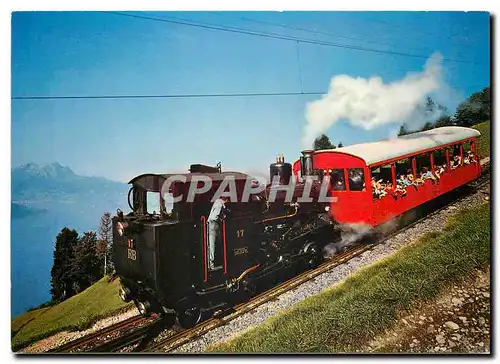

{"left": 11, "top": 277, "right": 133, "bottom": 350}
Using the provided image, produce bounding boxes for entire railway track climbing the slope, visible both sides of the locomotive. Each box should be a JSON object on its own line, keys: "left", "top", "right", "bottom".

{"left": 49, "top": 159, "right": 489, "bottom": 353}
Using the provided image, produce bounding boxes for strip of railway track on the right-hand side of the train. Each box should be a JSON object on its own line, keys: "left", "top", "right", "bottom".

{"left": 144, "top": 161, "right": 489, "bottom": 353}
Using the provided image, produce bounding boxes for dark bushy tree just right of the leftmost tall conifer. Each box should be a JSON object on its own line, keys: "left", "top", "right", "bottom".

{"left": 71, "top": 231, "right": 101, "bottom": 292}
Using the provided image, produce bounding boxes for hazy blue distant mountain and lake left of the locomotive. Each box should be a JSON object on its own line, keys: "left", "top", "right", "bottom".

{"left": 11, "top": 163, "right": 129, "bottom": 315}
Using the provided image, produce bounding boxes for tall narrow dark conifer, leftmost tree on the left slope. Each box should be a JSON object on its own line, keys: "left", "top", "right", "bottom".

{"left": 50, "top": 227, "right": 78, "bottom": 301}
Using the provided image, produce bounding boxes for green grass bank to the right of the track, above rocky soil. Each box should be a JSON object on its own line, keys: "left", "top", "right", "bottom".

{"left": 208, "top": 204, "right": 491, "bottom": 353}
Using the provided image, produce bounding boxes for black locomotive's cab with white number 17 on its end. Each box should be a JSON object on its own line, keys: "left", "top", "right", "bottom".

{"left": 113, "top": 165, "right": 264, "bottom": 324}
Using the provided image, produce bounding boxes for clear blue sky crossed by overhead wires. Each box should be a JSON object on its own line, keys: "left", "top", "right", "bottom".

{"left": 12, "top": 12, "right": 490, "bottom": 181}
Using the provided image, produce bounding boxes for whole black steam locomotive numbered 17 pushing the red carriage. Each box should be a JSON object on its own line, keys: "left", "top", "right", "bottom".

{"left": 113, "top": 152, "right": 334, "bottom": 327}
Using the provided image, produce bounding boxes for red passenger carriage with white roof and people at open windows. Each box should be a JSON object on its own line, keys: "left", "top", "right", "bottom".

{"left": 293, "top": 126, "right": 481, "bottom": 227}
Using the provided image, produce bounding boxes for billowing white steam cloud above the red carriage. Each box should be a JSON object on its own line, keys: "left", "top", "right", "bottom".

{"left": 302, "top": 53, "right": 447, "bottom": 148}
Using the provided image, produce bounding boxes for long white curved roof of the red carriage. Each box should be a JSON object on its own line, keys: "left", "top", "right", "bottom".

{"left": 315, "top": 126, "right": 481, "bottom": 165}
